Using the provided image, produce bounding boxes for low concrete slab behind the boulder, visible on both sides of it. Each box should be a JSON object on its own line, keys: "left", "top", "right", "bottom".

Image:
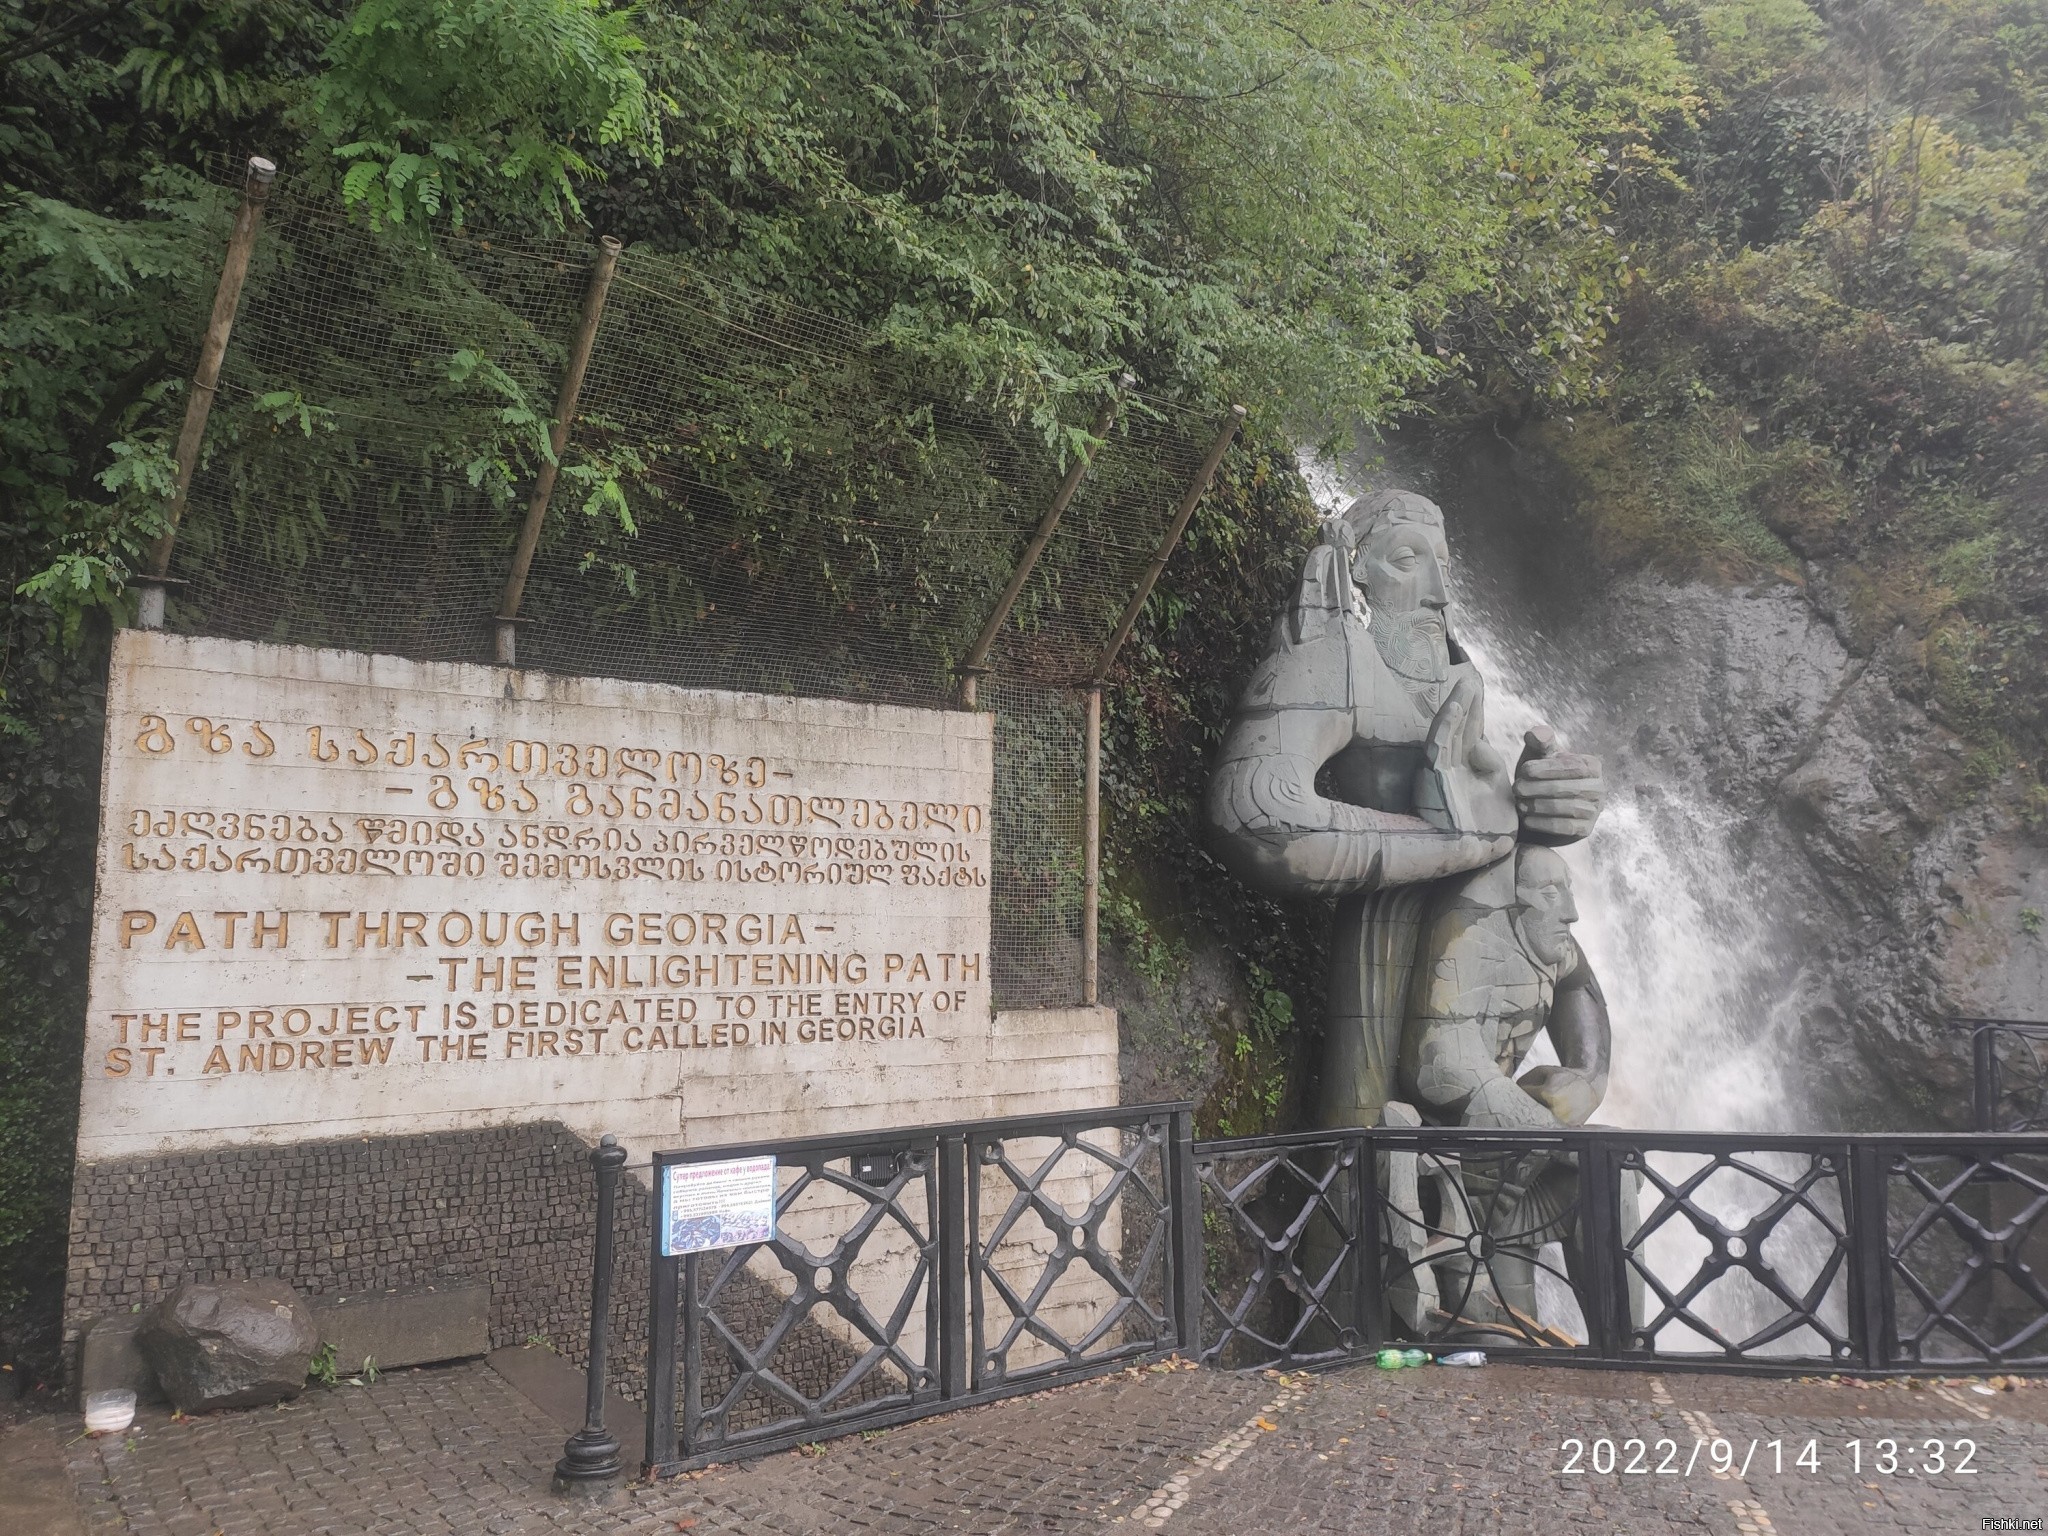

{"left": 78, "top": 1280, "right": 492, "bottom": 1403}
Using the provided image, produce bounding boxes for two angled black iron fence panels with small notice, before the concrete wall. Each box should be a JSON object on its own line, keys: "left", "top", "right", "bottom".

{"left": 645, "top": 1104, "right": 1198, "bottom": 1473}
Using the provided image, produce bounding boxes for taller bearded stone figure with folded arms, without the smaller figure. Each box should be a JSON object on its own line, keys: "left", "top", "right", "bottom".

{"left": 1206, "top": 492, "right": 1606, "bottom": 1128}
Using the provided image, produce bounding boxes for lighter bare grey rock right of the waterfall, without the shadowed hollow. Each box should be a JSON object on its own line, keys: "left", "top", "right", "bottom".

{"left": 1583, "top": 575, "right": 2048, "bottom": 1126}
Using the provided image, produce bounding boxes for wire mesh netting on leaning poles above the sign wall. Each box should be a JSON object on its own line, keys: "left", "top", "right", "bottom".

{"left": 168, "top": 177, "right": 1217, "bottom": 1008}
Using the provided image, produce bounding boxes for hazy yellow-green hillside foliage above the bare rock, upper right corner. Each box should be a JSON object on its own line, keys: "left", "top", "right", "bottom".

{"left": 1536, "top": 0, "right": 2048, "bottom": 799}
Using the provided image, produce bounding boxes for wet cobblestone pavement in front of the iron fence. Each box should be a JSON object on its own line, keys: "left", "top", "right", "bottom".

{"left": 32, "top": 1364, "right": 2048, "bottom": 1536}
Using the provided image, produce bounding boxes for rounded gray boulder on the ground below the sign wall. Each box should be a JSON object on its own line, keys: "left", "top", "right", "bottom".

{"left": 139, "top": 1280, "right": 319, "bottom": 1413}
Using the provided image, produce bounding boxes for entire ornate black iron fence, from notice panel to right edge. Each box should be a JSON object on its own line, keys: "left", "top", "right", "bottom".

{"left": 614, "top": 1104, "right": 2048, "bottom": 1470}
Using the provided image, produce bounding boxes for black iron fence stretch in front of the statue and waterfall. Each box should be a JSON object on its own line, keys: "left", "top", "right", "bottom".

{"left": 1194, "top": 1128, "right": 2048, "bottom": 1372}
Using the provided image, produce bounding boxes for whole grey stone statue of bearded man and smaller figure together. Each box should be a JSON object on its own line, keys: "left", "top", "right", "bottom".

{"left": 1206, "top": 492, "right": 1608, "bottom": 1331}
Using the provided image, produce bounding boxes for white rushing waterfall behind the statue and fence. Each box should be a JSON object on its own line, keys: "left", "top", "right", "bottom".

{"left": 1303, "top": 459, "right": 1845, "bottom": 1356}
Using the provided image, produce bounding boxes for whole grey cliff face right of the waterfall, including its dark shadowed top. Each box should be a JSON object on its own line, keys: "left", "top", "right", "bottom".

{"left": 1436, "top": 434, "right": 2048, "bottom": 1128}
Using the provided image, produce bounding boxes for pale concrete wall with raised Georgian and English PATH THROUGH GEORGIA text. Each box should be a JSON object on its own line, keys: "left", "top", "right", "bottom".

{"left": 80, "top": 631, "right": 1116, "bottom": 1161}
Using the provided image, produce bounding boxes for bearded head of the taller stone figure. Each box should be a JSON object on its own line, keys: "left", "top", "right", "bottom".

{"left": 1339, "top": 492, "right": 1452, "bottom": 682}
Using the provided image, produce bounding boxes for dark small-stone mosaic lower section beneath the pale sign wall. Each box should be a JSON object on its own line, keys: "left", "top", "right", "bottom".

{"left": 63, "top": 1124, "right": 887, "bottom": 1427}
